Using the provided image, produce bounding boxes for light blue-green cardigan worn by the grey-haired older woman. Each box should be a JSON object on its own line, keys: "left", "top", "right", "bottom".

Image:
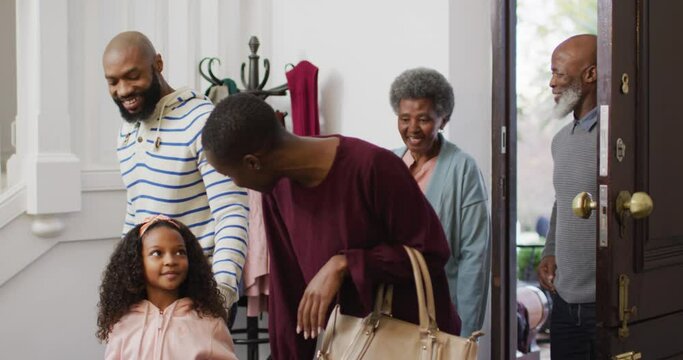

{"left": 394, "top": 134, "right": 491, "bottom": 337}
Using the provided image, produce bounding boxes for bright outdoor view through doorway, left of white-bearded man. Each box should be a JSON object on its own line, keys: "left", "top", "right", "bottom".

{"left": 511, "top": 0, "right": 598, "bottom": 359}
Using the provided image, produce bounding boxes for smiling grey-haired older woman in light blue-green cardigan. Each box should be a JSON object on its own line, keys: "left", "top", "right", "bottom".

{"left": 390, "top": 68, "right": 490, "bottom": 336}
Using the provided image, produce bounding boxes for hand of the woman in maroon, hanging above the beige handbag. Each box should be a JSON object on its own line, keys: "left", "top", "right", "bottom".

{"left": 296, "top": 255, "right": 347, "bottom": 339}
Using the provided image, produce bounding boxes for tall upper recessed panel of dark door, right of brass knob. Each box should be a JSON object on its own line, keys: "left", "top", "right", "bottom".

{"left": 636, "top": 0, "right": 683, "bottom": 269}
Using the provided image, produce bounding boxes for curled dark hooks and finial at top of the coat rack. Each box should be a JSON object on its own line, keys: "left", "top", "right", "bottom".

{"left": 199, "top": 36, "right": 288, "bottom": 99}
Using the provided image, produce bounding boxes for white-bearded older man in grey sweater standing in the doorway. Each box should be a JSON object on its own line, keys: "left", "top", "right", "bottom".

{"left": 538, "top": 35, "right": 598, "bottom": 360}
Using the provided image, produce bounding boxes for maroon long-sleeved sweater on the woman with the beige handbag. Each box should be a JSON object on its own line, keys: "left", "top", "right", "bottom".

{"left": 263, "top": 136, "right": 460, "bottom": 360}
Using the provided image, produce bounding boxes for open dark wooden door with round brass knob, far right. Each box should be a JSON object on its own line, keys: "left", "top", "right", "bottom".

{"left": 595, "top": 0, "right": 683, "bottom": 359}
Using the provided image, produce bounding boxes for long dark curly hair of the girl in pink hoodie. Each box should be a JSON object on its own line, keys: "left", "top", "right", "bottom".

{"left": 97, "top": 220, "right": 228, "bottom": 342}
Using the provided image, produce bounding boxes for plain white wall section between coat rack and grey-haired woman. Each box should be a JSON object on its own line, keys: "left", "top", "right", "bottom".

{"left": 266, "top": 0, "right": 449, "bottom": 148}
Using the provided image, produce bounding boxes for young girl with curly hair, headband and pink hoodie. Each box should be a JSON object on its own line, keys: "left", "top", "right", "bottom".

{"left": 97, "top": 215, "right": 237, "bottom": 360}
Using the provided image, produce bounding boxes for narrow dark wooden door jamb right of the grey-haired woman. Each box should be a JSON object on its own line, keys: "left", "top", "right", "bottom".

{"left": 489, "top": 0, "right": 517, "bottom": 359}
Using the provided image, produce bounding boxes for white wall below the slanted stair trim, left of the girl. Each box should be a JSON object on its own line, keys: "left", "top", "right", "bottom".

{"left": 0, "top": 239, "right": 115, "bottom": 359}
